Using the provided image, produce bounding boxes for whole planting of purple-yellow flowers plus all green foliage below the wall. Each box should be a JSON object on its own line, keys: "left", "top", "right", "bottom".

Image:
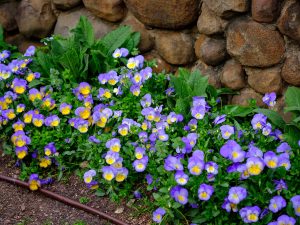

{"left": 0, "top": 18, "right": 300, "bottom": 225}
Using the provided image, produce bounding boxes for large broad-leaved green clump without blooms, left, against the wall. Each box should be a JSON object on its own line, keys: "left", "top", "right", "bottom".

{"left": 31, "top": 17, "right": 140, "bottom": 84}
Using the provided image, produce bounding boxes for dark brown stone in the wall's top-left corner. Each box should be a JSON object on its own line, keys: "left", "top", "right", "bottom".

{"left": 0, "top": 0, "right": 18, "bottom": 31}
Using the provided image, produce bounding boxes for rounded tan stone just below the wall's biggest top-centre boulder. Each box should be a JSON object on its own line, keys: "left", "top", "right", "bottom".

{"left": 154, "top": 31, "right": 195, "bottom": 65}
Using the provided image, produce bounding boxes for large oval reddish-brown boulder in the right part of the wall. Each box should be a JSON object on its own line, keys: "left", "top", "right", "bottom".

{"left": 227, "top": 19, "right": 285, "bottom": 67}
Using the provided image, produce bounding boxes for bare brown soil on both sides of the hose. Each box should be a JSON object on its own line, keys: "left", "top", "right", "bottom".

{"left": 0, "top": 155, "right": 151, "bottom": 225}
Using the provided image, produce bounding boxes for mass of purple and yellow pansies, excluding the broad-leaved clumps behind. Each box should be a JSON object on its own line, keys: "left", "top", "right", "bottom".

{"left": 0, "top": 43, "right": 300, "bottom": 224}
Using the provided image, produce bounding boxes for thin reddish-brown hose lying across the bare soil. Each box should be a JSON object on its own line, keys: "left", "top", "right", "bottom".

{"left": 0, "top": 174, "right": 129, "bottom": 225}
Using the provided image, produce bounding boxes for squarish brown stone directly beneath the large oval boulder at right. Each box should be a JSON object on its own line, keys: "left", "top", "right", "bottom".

{"left": 245, "top": 66, "right": 282, "bottom": 94}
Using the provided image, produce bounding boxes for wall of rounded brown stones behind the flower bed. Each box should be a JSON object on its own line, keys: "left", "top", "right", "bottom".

{"left": 0, "top": 0, "right": 300, "bottom": 107}
